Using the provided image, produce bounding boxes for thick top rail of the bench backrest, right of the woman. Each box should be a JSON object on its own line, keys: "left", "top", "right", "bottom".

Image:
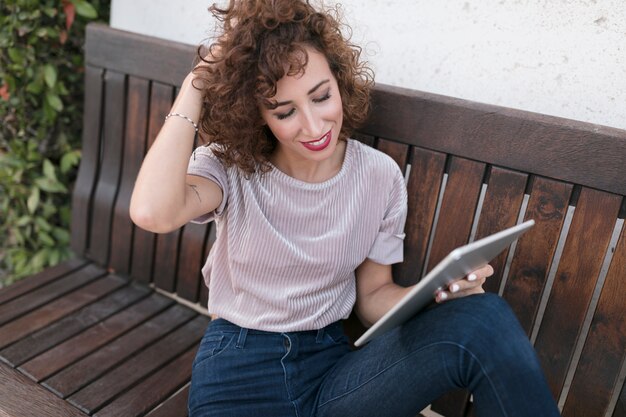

{"left": 362, "top": 84, "right": 626, "bottom": 195}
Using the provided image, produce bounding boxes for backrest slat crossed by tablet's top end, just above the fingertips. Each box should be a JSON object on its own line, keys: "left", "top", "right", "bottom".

{"left": 475, "top": 167, "right": 528, "bottom": 293}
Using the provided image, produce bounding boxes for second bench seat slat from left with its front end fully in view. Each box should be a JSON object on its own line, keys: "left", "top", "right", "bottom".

{"left": 43, "top": 305, "right": 195, "bottom": 398}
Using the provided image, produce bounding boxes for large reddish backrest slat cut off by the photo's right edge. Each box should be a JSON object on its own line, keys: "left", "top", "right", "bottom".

{"left": 563, "top": 221, "right": 626, "bottom": 417}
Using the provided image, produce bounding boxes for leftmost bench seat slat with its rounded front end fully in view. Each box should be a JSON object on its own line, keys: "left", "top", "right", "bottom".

{"left": 19, "top": 294, "right": 173, "bottom": 381}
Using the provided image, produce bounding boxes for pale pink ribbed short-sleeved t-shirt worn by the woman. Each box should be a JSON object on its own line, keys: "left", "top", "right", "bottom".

{"left": 188, "top": 139, "right": 407, "bottom": 332}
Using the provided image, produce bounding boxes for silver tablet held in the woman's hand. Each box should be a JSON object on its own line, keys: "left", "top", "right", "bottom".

{"left": 354, "top": 220, "right": 535, "bottom": 347}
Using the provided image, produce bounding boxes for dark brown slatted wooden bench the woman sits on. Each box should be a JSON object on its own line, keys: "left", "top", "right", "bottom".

{"left": 0, "top": 24, "right": 626, "bottom": 417}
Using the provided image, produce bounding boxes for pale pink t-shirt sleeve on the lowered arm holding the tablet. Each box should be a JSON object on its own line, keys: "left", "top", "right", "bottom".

{"left": 367, "top": 164, "right": 407, "bottom": 265}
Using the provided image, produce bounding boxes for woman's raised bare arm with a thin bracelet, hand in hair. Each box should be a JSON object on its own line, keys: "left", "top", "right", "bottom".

{"left": 130, "top": 74, "right": 222, "bottom": 233}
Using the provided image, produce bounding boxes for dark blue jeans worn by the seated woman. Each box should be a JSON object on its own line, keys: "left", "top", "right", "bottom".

{"left": 189, "top": 294, "right": 559, "bottom": 417}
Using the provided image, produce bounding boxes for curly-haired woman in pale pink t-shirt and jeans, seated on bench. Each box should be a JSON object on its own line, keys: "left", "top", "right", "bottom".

{"left": 131, "top": 0, "right": 558, "bottom": 417}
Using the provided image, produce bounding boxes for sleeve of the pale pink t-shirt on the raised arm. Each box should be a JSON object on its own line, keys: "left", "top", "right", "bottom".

{"left": 187, "top": 146, "right": 229, "bottom": 223}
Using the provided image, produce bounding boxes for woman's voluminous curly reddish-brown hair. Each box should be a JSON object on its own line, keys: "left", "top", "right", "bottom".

{"left": 194, "top": 0, "right": 373, "bottom": 175}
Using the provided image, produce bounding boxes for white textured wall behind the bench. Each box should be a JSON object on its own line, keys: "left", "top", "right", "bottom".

{"left": 111, "top": 0, "right": 626, "bottom": 129}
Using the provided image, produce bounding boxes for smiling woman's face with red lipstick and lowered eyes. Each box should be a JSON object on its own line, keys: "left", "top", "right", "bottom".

{"left": 261, "top": 48, "right": 343, "bottom": 166}
